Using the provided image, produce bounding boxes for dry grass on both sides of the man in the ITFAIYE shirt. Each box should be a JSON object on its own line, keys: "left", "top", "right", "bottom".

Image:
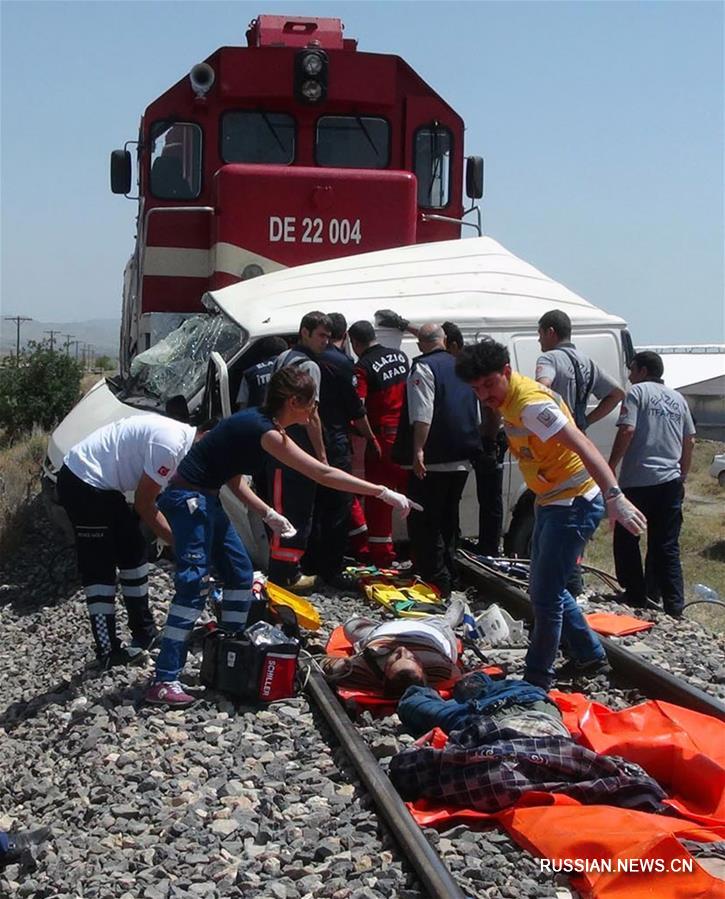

{"left": 586, "top": 440, "right": 725, "bottom": 633}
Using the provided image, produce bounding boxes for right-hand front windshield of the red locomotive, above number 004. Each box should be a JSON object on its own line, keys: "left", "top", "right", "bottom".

{"left": 315, "top": 116, "right": 390, "bottom": 169}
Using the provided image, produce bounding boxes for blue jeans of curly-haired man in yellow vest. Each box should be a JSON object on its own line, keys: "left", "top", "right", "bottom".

{"left": 524, "top": 494, "right": 606, "bottom": 690}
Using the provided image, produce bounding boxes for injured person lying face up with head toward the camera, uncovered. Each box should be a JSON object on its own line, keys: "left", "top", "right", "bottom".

{"left": 320, "top": 599, "right": 464, "bottom": 697}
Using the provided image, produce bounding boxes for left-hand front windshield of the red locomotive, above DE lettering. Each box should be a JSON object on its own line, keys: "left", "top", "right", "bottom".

{"left": 221, "top": 111, "right": 295, "bottom": 165}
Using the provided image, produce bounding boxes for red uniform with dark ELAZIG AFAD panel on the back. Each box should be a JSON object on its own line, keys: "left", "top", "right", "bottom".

{"left": 354, "top": 344, "right": 410, "bottom": 568}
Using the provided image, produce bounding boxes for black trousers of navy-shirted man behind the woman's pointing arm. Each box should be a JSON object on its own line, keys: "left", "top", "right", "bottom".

{"left": 302, "top": 434, "right": 352, "bottom": 578}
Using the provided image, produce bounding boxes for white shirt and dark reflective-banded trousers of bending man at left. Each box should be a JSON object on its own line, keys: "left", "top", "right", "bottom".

{"left": 58, "top": 413, "right": 196, "bottom": 657}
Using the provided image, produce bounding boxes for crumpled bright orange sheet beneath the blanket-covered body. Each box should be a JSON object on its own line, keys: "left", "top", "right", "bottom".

{"left": 408, "top": 690, "right": 725, "bottom": 899}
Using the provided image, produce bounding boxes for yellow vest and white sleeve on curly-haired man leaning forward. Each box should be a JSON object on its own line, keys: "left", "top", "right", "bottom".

{"left": 499, "top": 372, "right": 599, "bottom": 506}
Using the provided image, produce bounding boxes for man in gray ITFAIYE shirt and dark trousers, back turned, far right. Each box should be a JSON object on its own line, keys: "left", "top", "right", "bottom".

{"left": 609, "top": 350, "right": 695, "bottom": 618}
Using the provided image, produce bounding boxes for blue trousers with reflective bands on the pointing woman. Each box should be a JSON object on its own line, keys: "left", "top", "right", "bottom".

{"left": 156, "top": 487, "right": 254, "bottom": 683}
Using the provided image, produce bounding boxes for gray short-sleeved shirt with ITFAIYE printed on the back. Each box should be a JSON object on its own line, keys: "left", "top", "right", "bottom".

{"left": 617, "top": 381, "right": 695, "bottom": 487}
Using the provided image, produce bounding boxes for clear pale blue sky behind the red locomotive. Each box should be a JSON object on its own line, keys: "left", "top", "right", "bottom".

{"left": 0, "top": 0, "right": 725, "bottom": 344}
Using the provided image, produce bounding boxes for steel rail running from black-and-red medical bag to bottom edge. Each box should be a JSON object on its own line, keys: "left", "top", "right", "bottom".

{"left": 305, "top": 665, "right": 465, "bottom": 899}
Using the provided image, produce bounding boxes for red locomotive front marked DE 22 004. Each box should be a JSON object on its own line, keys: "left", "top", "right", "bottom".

{"left": 112, "top": 16, "right": 463, "bottom": 375}
